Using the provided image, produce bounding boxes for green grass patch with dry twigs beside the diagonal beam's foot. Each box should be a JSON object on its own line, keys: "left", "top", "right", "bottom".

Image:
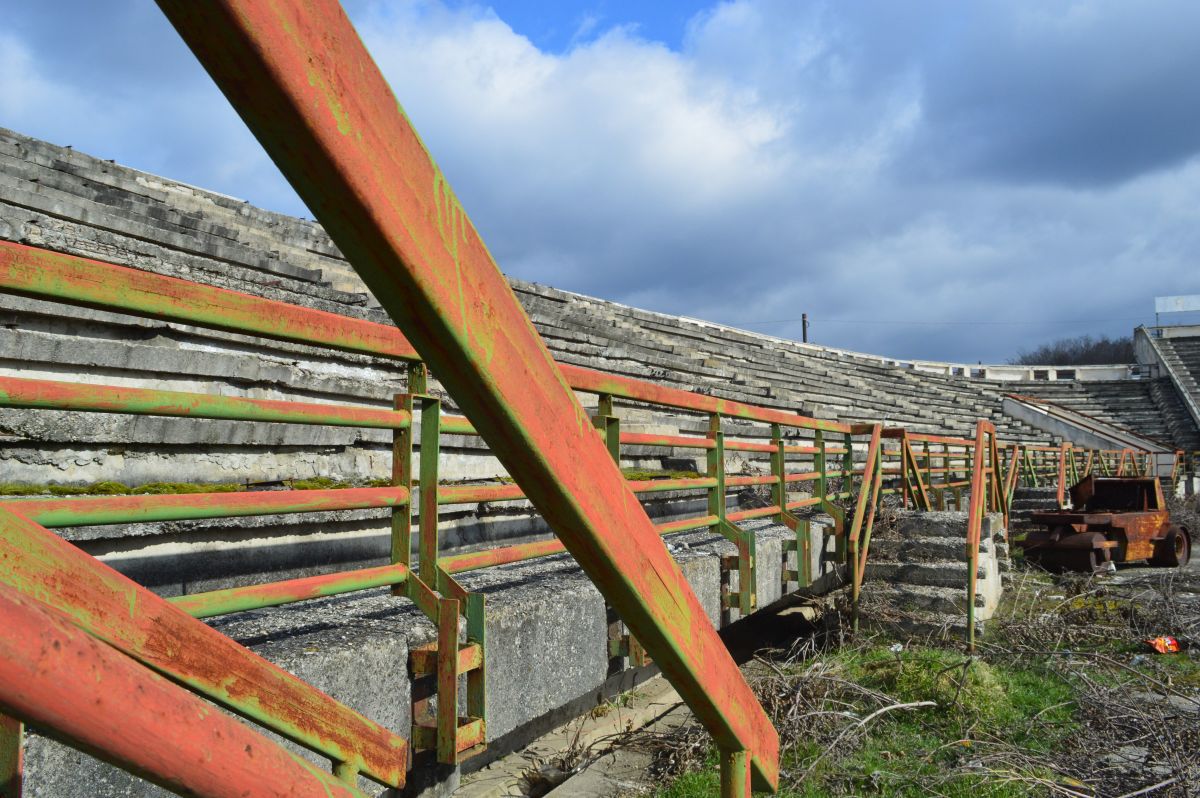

{"left": 654, "top": 642, "right": 1078, "bottom": 798}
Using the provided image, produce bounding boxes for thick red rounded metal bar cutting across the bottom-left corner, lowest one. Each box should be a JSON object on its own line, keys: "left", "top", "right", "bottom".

{"left": 0, "top": 584, "right": 369, "bottom": 798}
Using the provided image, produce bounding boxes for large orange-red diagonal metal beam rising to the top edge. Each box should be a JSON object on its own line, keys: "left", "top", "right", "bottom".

{"left": 158, "top": 0, "right": 779, "bottom": 788}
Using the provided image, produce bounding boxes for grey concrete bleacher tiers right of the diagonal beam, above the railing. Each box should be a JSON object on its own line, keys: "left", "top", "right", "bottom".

{"left": 518, "top": 284, "right": 1050, "bottom": 443}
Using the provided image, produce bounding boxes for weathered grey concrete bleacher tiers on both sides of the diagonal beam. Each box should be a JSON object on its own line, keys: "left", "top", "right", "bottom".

{"left": 7, "top": 124, "right": 1195, "bottom": 578}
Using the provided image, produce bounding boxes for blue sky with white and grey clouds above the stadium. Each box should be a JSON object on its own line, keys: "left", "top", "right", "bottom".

{"left": 0, "top": 0, "right": 1200, "bottom": 362}
